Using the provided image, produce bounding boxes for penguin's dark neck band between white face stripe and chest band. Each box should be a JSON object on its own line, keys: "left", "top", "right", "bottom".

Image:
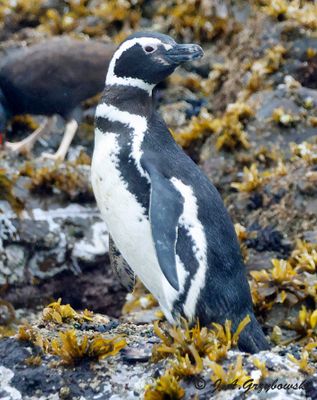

{"left": 102, "top": 85, "right": 153, "bottom": 117}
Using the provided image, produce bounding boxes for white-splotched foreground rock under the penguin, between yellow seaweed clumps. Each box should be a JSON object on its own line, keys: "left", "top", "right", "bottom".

{"left": 0, "top": 316, "right": 315, "bottom": 400}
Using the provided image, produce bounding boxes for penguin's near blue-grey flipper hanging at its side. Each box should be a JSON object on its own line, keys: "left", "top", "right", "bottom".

{"left": 144, "top": 161, "right": 183, "bottom": 290}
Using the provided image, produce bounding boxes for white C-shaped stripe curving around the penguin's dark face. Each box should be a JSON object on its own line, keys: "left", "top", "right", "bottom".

{"left": 106, "top": 37, "right": 172, "bottom": 94}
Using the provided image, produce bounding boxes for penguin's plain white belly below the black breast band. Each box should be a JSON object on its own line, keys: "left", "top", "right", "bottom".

{"left": 91, "top": 129, "right": 178, "bottom": 321}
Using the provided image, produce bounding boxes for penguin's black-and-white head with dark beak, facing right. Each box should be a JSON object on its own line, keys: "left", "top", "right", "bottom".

{"left": 106, "top": 32, "right": 203, "bottom": 92}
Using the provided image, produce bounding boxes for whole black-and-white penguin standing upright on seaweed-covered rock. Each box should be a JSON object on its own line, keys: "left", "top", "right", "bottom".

{"left": 92, "top": 32, "right": 268, "bottom": 353}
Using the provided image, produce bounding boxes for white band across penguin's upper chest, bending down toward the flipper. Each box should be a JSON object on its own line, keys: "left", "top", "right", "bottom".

{"left": 96, "top": 103, "right": 150, "bottom": 181}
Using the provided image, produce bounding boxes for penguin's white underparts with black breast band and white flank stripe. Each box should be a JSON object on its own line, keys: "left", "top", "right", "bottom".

{"left": 92, "top": 103, "right": 207, "bottom": 321}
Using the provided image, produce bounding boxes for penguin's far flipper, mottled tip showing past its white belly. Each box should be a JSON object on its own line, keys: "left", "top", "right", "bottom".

{"left": 109, "top": 235, "right": 135, "bottom": 292}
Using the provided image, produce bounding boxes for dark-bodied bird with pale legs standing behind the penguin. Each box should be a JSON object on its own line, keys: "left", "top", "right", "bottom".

{"left": 0, "top": 37, "right": 115, "bottom": 160}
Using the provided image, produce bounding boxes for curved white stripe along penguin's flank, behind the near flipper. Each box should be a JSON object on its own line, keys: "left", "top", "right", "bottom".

{"left": 171, "top": 177, "right": 208, "bottom": 318}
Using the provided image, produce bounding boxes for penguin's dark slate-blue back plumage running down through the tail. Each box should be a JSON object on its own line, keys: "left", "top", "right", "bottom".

{"left": 142, "top": 113, "right": 268, "bottom": 352}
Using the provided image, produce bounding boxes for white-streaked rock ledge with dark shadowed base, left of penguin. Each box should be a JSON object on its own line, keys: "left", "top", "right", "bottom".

{"left": 0, "top": 196, "right": 125, "bottom": 316}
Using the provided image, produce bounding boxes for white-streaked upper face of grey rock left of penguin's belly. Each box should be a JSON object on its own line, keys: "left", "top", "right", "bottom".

{"left": 0, "top": 204, "right": 108, "bottom": 283}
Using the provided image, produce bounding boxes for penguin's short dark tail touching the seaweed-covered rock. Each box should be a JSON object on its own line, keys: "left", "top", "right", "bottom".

{"left": 238, "top": 313, "right": 270, "bottom": 354}
